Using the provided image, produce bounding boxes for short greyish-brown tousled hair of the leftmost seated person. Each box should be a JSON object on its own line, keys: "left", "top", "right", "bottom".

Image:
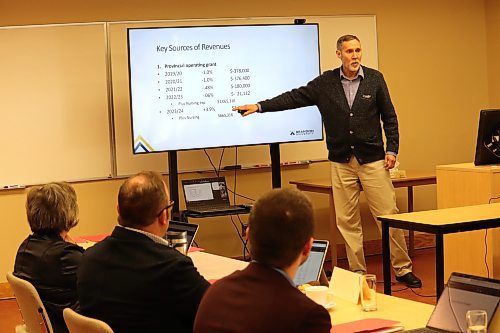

{"left": 26, "top": 183, "right": 78, "bottom": 234}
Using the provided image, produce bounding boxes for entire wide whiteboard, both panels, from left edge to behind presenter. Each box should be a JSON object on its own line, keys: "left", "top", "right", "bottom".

{"left": 0, "top": 15, "right": 378, "bottom": 185}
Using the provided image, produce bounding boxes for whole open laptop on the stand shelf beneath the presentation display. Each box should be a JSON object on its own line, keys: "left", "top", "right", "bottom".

{"left": 182, "top": 177, "right": 249, "bottom": 215}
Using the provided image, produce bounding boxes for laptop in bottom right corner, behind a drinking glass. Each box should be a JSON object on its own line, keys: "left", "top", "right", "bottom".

{"left": 405, "top": 273, "right": 500, "bottom": 333}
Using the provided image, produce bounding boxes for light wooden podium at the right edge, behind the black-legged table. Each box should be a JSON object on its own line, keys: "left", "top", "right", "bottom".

{"left": 436, "top": 163, "right": 500, "bottom": 279}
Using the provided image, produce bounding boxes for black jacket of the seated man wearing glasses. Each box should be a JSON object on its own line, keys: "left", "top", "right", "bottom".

{"left": 78, "top": 226, "right": 209, "bottom": 333}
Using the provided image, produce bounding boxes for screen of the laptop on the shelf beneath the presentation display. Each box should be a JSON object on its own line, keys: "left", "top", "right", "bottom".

{"left": 182, "top": 177, "right": 229, "bottom": 209}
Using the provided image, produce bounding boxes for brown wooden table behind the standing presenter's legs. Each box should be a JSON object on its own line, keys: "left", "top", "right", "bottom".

{"left": 290, "top": 170, "right": 436, "bottom": 266}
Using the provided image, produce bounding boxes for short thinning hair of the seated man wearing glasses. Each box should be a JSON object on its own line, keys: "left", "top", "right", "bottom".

{"left": 118, "top": 171, "right": 168, "bottom": 227}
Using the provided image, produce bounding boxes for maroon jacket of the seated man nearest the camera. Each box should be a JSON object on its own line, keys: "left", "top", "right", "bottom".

{"left": 194, "top": 263, "right": 331, "bottom": 333}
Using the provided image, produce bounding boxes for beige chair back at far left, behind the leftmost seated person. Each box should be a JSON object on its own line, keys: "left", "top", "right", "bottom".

{"left": 7, "top": 272, "right": 54, "bottom": 333}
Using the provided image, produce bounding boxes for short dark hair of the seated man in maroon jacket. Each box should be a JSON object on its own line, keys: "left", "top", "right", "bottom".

{"left": 248, "top": 189, "right": 314, "bottom": 268}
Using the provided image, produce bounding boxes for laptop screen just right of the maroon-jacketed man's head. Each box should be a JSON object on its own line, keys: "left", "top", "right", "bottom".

{"left": 293, "top": 239, "right": 328, "bottom": 285}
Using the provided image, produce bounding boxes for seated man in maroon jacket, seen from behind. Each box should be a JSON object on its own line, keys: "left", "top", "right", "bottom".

{"left": 194, "top": 189, "right": 331, "bottom": 333}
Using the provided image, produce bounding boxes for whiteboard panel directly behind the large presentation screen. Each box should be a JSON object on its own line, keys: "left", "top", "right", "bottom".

{"left": 109, "top": 15, "right": 378, "bottom": 175}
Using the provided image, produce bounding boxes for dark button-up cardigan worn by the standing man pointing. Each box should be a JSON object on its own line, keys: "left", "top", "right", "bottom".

{"left": 259, "top": 66, "right": 399, "bottom": 164}
